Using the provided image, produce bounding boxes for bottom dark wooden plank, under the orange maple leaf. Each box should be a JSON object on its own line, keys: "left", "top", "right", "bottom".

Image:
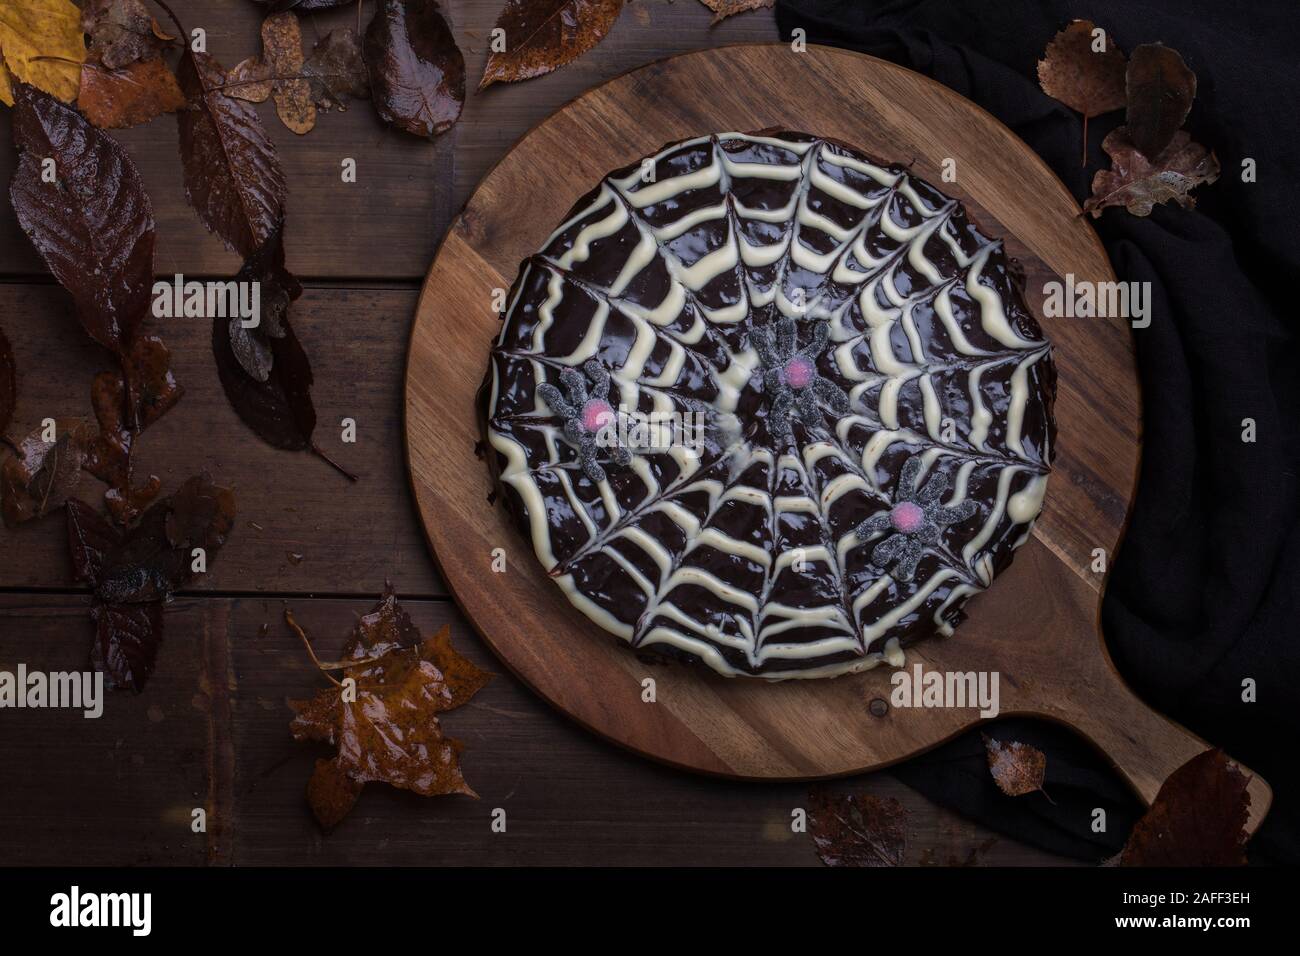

{"left": 0, "top": 596, "right": 1056, "bottom": 866}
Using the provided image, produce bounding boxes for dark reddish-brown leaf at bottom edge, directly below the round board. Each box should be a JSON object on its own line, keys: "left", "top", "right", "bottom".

{"left": 807, "top": 787, "right": 907, "bottom": 866}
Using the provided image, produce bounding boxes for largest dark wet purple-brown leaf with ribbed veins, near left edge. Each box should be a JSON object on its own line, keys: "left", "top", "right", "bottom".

{"left": 9, "top": 85, "right": 153, "bottom": 356}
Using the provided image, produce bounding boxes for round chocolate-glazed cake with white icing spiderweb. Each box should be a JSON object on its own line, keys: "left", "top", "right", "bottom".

{"left": 482, "top": 131, "right": 1056, "bottom": 679}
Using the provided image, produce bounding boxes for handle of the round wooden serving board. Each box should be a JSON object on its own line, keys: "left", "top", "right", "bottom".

{"left": 1045, "top": 635, "right": 1273, "bottom": 834}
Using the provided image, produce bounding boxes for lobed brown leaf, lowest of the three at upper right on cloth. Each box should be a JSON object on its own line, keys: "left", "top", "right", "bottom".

{"left": 1083, "top": 126, "right": 1219, "bottom": 216}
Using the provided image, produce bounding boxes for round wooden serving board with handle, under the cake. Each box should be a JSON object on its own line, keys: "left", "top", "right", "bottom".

{"left": 406, "top": 44, "right": 1271, "bottom": 826}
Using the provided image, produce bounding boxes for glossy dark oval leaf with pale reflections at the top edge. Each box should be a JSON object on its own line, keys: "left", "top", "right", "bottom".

{"left": 365, "top": 0, "right": 465, "bottom": 139}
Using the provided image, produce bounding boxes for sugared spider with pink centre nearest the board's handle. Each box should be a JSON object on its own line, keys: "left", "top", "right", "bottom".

{"left": 854, "top": 455, "right": 979, "bottom": 581}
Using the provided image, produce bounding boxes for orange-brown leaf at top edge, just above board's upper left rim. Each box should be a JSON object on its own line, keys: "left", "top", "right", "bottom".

{"left": 478, "top": 0, "right": 623, "bottom": 90}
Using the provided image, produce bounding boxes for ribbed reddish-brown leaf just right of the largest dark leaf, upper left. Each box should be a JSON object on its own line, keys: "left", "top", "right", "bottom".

{"left": 177, "top": 51, "right": 287, "bottom": 259}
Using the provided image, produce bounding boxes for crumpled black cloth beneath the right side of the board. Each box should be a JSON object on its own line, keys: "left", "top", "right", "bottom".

{"left": 777, "top": 0, "right": 1300, "bottom": 864}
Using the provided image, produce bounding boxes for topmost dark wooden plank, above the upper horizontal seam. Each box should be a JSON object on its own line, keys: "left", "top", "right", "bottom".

{"left": 0, "top": 0, "right": 775, "bottom": 280}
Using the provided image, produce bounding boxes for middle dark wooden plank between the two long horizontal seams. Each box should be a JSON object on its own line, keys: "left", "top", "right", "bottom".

{"left": 0, "top": 284, "right": 446, "bottom": 594}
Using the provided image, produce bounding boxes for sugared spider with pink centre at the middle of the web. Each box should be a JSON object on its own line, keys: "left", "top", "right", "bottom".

{"left": 750, "top": 316, "right": 849, "bottom": 441}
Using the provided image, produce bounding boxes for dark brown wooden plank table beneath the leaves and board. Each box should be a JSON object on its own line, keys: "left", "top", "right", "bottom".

{"left": 0, "top": 0, "right": 1061, "bottom": 865}
